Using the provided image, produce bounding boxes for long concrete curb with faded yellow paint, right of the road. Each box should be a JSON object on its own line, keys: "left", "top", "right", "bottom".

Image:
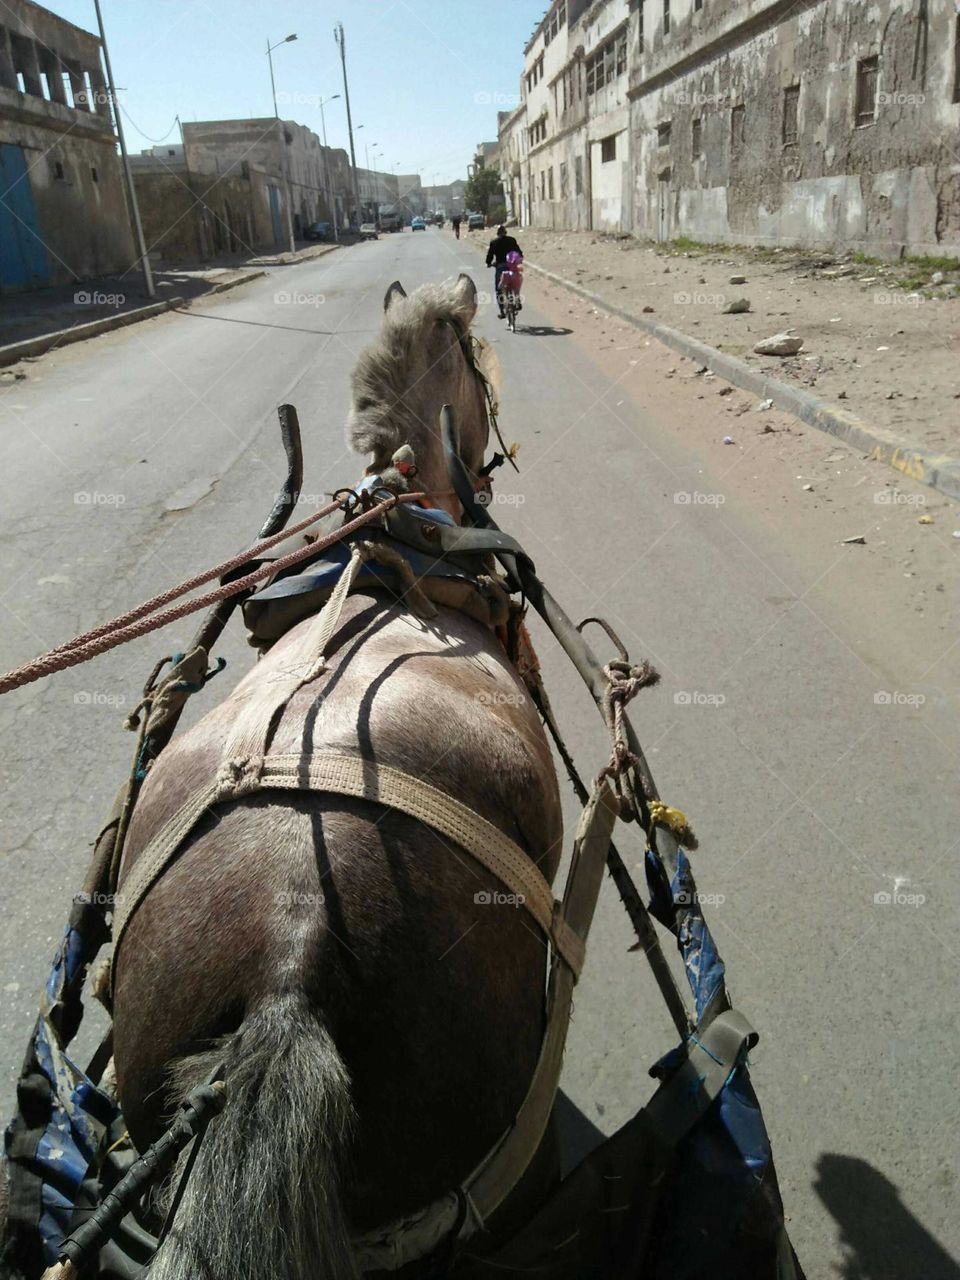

{"left": 525, "top": 260, "right": 960, "bottom": 502}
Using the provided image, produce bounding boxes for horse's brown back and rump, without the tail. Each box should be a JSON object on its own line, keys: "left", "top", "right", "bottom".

{"left": 115, "top": 594, "right": 561, "bottom": 1226}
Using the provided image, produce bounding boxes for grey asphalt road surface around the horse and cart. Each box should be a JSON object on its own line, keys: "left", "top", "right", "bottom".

{"left": 0, "top": 229, "right": 960, "bottom": 1280}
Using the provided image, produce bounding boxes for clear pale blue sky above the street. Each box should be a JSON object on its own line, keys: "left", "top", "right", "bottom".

{"left": 37, "top": 0, "right": 547, "bottom": 183}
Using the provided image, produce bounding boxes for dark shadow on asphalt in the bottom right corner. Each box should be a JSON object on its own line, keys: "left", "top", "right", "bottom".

{"left": 813, "top": 1153, "right": 960, "bottom": 1280}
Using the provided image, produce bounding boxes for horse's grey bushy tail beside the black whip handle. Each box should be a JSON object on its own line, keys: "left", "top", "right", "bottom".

{"left": 148, "top": 993, "right": 358, "bottom": 1280}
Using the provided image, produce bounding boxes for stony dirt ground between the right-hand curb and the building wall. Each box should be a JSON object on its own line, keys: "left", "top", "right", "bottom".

{"left": 520, "top": 230, "right": 960, "bottom": 456}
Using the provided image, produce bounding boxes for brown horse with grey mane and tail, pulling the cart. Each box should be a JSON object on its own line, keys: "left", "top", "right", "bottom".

{"left": 113, "top": 275, "right": 562, "bottom": 1280}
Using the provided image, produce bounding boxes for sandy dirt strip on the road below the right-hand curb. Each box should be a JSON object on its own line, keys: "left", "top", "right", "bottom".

{"left": 504, "top": 257, "right": 960, "bottom": 680}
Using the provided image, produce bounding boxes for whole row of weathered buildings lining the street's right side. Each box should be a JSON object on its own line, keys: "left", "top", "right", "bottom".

{"left": 500, "top": 0, "right": 960, "bottom": 255}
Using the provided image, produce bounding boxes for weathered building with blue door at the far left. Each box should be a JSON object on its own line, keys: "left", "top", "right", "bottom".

{"left": 0, "top": 0, "right": 136, "bottom": 292}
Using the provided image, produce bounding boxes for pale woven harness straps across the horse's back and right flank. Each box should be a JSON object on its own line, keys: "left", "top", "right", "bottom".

{"left": 111, "top": 527, "right": 617, "bottom": 1271}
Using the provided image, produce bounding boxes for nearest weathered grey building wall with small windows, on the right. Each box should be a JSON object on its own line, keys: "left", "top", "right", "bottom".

{"left": 631, "top": 0, "right": 960, "bottom": 256}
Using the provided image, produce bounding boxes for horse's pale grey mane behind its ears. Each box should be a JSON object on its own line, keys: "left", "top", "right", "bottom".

{"left": 347, "top": 280, "right": 476, "bottom": 462}
